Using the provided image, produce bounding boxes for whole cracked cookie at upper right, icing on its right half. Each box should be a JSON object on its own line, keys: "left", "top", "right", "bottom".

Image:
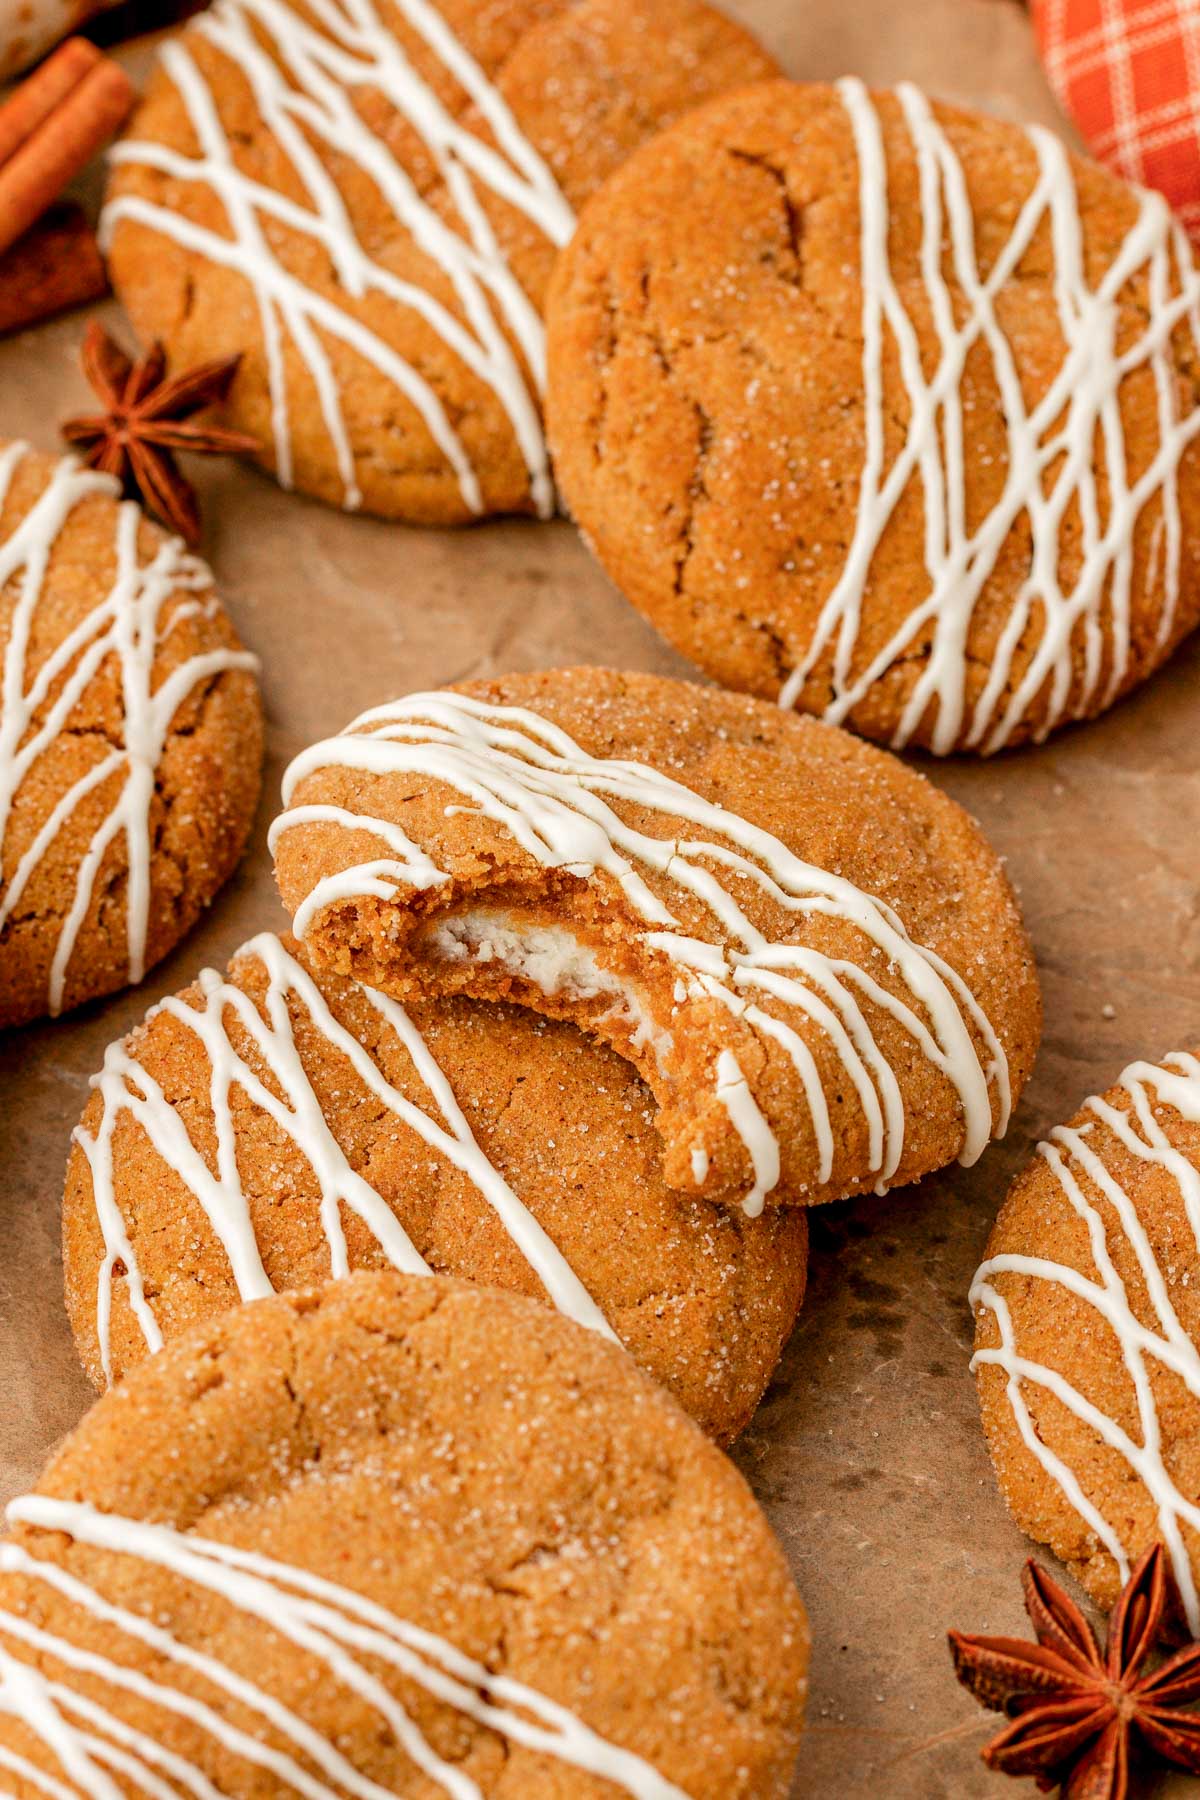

{"left": 547, "top": 79, "right": 1200, "bottom": 752}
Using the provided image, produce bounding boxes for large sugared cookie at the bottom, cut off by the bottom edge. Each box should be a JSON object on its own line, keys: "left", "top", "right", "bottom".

{"left": 0, "top": 1274, "right": 808, "bottom": 1800}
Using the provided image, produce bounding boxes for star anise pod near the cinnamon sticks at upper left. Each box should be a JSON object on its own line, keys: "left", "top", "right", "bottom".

{"left": 63, "top": 319, "right": 259, "bottom": 544}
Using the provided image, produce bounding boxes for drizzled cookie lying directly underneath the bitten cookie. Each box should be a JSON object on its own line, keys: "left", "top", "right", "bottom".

{"left": 63, "top": 932, "right": 808, "bottom": 1442}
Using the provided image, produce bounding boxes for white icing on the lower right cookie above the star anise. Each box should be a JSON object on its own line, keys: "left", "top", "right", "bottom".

{"left": 970, "top": 1055, "right": 1200, "bottom": 1633}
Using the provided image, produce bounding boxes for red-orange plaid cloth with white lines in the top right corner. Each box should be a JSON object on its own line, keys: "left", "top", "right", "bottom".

{"left": 1033, "top": 0, "right": 1200, "bottom": 241}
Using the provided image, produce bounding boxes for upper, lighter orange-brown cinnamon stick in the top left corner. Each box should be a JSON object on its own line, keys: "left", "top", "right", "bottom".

{"left": 0, "top": 38, "right": 135, "bottom": 254}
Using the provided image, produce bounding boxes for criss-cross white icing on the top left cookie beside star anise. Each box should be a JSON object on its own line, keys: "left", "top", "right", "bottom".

{"left": 104, "top": 0, "right": 574, "bottom": 517}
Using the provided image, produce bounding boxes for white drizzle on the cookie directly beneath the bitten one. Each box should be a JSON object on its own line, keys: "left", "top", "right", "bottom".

{"left": 76, "top": 932, "right": 613, "bottom": 1381}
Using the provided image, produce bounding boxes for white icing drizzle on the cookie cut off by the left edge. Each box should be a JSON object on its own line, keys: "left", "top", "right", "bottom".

{"left": 0, "top": 443, "right": 259, "bottom": 1013}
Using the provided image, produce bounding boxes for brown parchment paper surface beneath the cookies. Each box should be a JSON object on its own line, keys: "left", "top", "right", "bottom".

{"left": 0, "top": 0, "right": 1200, "bottom": 1800}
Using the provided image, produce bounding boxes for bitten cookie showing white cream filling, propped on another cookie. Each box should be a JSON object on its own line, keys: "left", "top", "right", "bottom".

{"left": 272, "top": 668, "right": 1040, "bottom": 1213}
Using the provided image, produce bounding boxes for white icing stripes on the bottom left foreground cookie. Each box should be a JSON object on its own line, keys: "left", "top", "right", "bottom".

{"left": 0, "top": 1494, "right": 687, "bottom": 1800}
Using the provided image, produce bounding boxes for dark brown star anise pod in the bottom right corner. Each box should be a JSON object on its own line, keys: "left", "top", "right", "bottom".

{"left": 950, "top": 1544, "right": 1200, "bottom": 1800}
